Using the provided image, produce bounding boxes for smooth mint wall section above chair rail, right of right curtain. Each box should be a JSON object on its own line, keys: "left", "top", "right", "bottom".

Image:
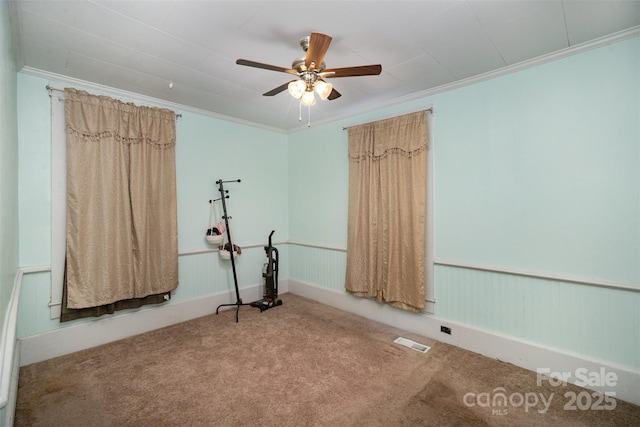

{"left": 434, "top": 38, "right": 640, "bottom": 283}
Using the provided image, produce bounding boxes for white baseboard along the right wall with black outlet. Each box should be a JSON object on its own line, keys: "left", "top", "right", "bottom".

{"left": 288, "top": 279, "right": 640, "bottom": 405}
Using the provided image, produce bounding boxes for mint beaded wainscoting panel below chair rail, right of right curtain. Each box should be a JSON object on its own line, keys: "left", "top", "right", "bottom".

{"left": 435, "top": 265, "right": 640, "bottom": 369}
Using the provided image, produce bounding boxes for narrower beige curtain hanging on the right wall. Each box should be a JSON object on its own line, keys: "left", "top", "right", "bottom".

{"left": 345, "top": 111, "right": 428, "bottom": 311}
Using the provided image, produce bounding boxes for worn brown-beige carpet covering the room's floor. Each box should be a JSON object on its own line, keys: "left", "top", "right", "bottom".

{"left": 15, "top": 294, "right": 640, "bottom": 427}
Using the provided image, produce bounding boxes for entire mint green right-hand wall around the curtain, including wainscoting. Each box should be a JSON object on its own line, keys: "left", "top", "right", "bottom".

{"left": 289, "top": 37, "right": 640, "bottom": 369}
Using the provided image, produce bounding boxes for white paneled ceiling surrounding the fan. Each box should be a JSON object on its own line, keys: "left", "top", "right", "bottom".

{"left": 10, "top": 0, "right": 640, "bottom": 131}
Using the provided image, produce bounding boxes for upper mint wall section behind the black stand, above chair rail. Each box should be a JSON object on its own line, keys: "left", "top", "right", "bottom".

{"left": 176, "top": 113, "right": 289, "bottom": 250}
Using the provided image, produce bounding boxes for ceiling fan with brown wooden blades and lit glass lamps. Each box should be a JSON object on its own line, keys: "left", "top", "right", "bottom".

{"left": 236, "top": 32, "right": 382, "bottom": 106}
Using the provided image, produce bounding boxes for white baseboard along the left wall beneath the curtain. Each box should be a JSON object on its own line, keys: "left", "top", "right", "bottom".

{"left": 19, "top": 281, "right": 276, "bottom": 366}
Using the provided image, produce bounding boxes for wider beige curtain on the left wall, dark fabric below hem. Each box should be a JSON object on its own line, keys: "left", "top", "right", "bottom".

{"left": 63, "top": 89, "right": 178, "bottom": 317}
